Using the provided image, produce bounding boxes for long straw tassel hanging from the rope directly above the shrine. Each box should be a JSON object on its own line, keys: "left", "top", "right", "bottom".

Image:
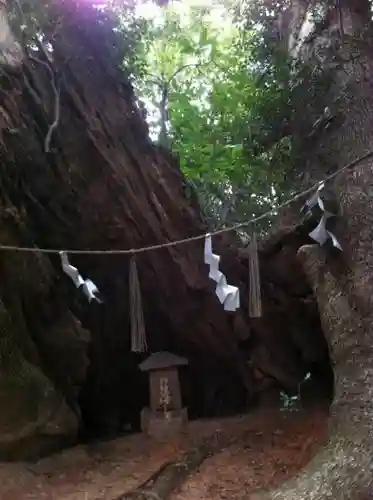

{"left": 129, "top": 256, "right": 148, "bottom": 352}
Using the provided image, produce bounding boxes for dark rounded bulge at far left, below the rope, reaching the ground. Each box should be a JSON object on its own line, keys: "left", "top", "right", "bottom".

{"left": 0, "top": 221, "right": 89, "bottom": 459}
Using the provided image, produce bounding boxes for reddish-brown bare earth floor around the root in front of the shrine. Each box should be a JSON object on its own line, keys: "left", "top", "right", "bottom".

{"left": 0, "top": 408, "right": 327, "bottom": 500}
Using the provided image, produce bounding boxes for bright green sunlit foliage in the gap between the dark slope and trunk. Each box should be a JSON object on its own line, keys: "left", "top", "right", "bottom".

{"left": 135, "top": 2, "right": 291, "bottom": 226}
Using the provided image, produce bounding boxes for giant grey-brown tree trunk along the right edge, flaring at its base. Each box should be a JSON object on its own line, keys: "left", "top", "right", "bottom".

{"left": 251, "top": 2, "right": 373, "bottom": 500}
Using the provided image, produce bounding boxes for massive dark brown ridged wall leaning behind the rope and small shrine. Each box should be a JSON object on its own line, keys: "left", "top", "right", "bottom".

{"left": 0, "top": 0, "right": 327, "bottom": 458}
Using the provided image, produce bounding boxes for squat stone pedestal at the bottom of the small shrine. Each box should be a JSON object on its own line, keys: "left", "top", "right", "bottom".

{"left": 141, "top": 408, "right": 188, "bottom": 440}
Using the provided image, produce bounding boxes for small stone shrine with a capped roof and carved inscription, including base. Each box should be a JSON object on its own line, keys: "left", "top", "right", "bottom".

{"left": 139, "top": 351, "right": 188, "bottom": 439}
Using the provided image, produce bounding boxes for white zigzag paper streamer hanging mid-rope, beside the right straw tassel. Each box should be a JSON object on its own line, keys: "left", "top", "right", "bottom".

{"left": 204, "top": 233, "right": 240, "bottom": 311}
